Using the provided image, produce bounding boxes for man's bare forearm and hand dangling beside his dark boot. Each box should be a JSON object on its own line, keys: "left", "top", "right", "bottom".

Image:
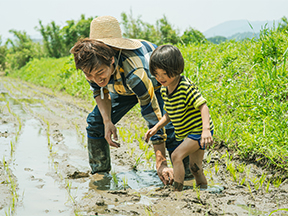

{"left": 95, "top": 93, "right": 120, "bottom": 148}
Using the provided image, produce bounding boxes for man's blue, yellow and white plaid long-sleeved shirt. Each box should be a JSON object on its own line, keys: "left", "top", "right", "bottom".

{"left": 88, "top": 40, "right": 166, "bottom": 144}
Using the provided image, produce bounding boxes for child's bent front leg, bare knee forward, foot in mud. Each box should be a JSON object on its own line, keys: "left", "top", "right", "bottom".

{"left": 171, "top": 138, "right": 199, "bottom": 191}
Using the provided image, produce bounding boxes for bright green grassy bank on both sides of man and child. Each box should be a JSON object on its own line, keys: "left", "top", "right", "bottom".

{"left": 9, "top": 30, "right": 288, "bottom": 170}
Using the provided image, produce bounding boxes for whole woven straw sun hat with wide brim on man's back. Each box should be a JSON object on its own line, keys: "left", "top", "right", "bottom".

{"left": 90, "top": 16, "right": 142, "bottom": 50}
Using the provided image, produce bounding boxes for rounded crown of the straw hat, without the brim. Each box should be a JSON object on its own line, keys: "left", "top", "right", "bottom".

{"left": 90, "top": 16, "right": 122, "bottom": 39}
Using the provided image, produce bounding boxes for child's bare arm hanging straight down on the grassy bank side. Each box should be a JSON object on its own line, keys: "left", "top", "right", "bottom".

{"left": 199, "top": 103, "right": 213, "bottom": 148}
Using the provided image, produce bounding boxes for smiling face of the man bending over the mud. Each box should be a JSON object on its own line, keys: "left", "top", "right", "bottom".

{"left": 83, "top": 58, "right": 114, "bottom": 87}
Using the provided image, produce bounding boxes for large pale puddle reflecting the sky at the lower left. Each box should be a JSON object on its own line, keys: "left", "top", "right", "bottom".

{"left": 12, "top": 119, "right": 70, "bottom": 215}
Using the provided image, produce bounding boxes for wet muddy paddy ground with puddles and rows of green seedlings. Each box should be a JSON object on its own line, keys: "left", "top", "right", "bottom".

{"left": 0, "top": 77, "right": 288, "bottom": 215}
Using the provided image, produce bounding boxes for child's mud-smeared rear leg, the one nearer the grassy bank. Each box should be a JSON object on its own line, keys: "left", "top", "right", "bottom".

{"left": 189, "top": 149, "right": 207, "bottom": 188}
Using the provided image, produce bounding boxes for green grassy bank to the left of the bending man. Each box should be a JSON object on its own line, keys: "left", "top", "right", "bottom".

{"left": 9, "top": 56, "right": 94, "bottom": 101}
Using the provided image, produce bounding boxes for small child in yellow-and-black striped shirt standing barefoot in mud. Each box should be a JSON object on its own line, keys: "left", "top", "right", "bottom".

{"left": 145, "top": 45, "right": 214, "bottom": 191}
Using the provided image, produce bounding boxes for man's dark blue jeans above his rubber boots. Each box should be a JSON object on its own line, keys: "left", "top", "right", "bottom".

{"left": 86, "top": 89, "right": 181, "bottom": 153}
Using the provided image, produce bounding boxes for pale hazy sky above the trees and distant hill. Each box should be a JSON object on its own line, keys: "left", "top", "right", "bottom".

{"left": 0, "top": 0, "right": 288, "bottom": 40}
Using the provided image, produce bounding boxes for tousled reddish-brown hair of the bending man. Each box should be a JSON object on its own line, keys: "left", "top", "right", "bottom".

{"left": 70, "top": 38, "right": 115, "bottom": 73}
